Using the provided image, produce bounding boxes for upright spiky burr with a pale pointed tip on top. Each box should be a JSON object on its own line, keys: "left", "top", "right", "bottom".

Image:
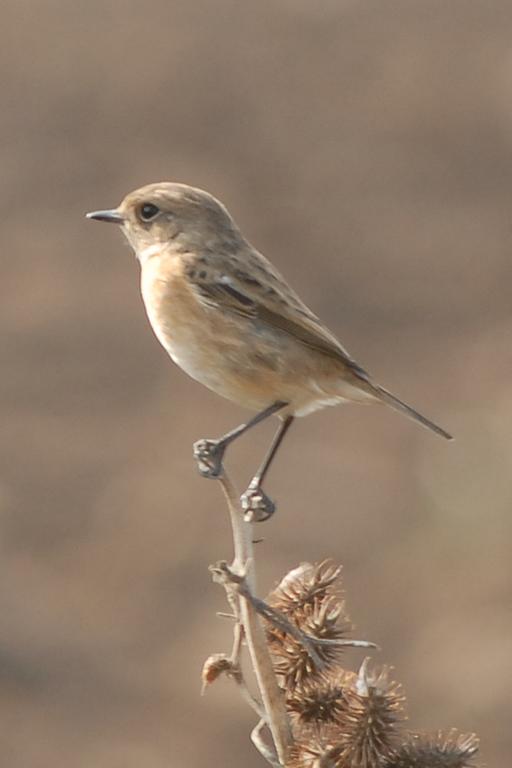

{"left": 340, "top": 659, "right": 405, "bottom": 768}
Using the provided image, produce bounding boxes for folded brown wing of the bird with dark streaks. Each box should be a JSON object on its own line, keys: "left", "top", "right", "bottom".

{"left": 189, "top": 252, "right": 368, "bottom": 381}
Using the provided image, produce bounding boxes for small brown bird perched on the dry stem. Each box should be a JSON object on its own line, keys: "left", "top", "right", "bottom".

{"left": 87, "top": 182, "right": 451, "bottom": 520}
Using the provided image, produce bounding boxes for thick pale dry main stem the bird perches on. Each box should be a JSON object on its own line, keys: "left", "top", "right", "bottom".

{"left": 219, "top": 471, "right": 292, "bottom": 765}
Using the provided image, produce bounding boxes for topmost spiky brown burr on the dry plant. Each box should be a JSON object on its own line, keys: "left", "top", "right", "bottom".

{"left": 267, "top": 560, "right": 341, "bottom": 615}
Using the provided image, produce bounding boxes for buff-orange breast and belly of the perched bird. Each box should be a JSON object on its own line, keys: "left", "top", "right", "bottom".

{"left": 141, "top": 257, "right": 352, "bottom": 415}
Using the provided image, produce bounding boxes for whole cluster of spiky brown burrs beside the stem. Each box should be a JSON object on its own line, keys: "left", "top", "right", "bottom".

{"left": 267, "top": 562, "right": 478, "bottom": 768}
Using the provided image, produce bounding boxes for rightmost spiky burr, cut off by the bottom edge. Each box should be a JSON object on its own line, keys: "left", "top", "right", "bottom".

{"left": 384, "top": 729, "right": 478, "bottom": 768}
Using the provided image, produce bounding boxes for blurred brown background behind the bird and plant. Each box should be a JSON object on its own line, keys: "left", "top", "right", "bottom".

{"left": 0, "top": 0, "right": 512, "bottom": 768}
